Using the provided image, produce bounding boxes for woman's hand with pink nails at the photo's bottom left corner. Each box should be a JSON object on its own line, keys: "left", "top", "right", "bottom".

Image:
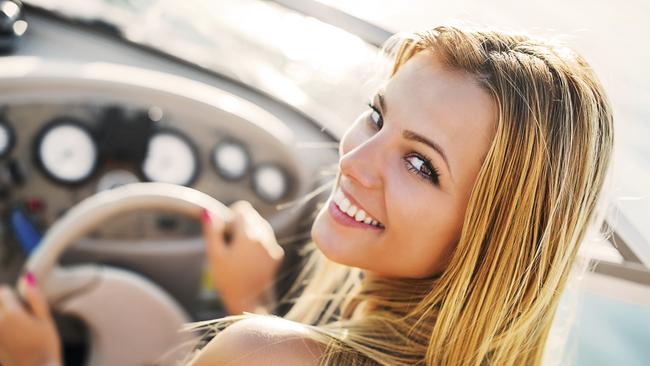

{"left": 0, "top": 272, "right": 61, "bottom": 366}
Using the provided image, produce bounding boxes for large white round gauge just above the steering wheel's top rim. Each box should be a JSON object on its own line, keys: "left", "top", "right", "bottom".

{"left": 142, "top": 131, "right": 199, "bottom": 185}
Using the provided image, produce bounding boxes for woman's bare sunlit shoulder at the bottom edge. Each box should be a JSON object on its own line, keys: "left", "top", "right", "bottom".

{"left": 190, "top": 316, "right": 322, "bottom": 366}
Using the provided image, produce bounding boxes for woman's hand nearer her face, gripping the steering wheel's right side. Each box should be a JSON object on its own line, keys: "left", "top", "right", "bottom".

{"left": 202, "top": 201, "right": 284, "bottom": 314}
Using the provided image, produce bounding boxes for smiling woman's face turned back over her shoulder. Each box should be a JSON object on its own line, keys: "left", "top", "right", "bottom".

{"left": 312, "top": 51, "right": 496, "bottom": 278}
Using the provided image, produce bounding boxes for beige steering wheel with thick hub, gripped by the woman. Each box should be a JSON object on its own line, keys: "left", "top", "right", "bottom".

{"left": 19, "top": 183, "right": 230, "bottom": 366}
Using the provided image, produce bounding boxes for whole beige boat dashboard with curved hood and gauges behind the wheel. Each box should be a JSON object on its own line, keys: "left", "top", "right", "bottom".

{"left": 0, "top": 5, "right": 338, "bottom": 319}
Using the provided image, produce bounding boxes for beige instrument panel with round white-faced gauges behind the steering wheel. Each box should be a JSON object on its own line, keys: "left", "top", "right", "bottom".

{"left": 0, "top": 98, "right": 322, "bottom": 239}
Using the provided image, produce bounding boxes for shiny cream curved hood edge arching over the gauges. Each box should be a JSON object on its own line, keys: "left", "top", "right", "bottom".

{"left": 0, "top": 56, "right": 294, "bottom": 145}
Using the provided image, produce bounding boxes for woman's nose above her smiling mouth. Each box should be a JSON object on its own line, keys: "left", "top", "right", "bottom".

{"left": 339, "top": 132, "right": 383, "bottom": 189}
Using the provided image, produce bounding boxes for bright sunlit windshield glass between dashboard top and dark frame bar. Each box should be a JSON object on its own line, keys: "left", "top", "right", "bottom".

{"left": 27, "top": 0, "right": 377, "bottom": 136}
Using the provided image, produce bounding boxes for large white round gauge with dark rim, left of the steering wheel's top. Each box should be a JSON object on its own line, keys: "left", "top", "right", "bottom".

{"left": 36, "top": 119, "right": 98, "bottom": 184}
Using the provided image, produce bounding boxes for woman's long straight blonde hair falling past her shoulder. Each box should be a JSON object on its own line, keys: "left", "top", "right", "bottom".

{"left": 286, "top": 26, "right": 613, "bottom": 365}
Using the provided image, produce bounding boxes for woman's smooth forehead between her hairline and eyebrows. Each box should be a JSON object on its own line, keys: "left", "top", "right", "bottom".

{"left": 384, "top": 51, "right": 496, "bottom": 181}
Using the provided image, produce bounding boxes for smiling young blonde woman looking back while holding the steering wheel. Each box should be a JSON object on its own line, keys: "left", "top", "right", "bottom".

{"left": 0, "top": 27, "right": 613, "bottom": 365}
